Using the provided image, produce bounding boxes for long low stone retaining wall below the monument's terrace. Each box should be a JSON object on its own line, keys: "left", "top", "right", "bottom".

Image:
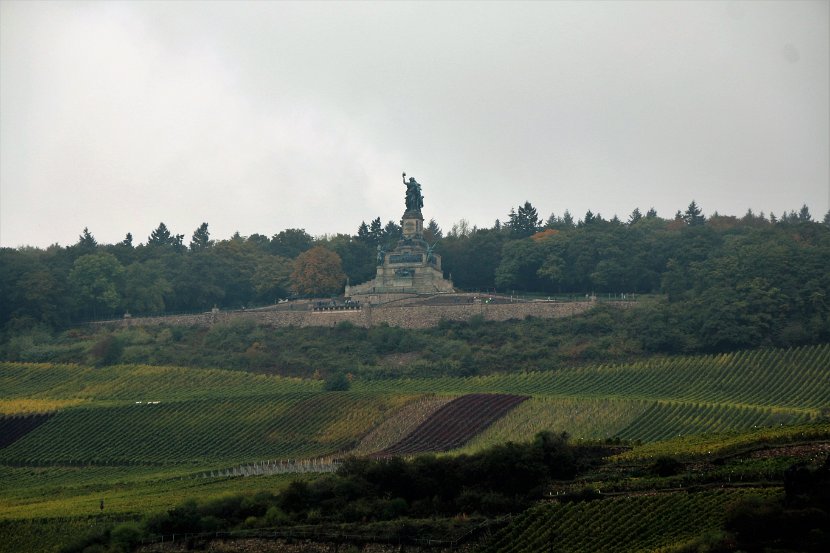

{"left": 101, "top": 301, "right": 608, "bottom": 328}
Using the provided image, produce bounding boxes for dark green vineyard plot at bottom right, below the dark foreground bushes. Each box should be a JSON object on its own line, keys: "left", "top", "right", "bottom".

{"left": 482, "top": 489, "right": 778, "bottom": 553}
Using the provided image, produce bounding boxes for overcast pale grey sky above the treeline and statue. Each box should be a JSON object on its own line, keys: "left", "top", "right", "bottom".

{"left": 0, "top": 0, "right": 830, "bottom": 247}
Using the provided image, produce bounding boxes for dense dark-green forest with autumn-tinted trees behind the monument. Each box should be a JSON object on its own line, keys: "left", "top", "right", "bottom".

{"left": 0, "top": 202, "right": 830, "bottom": 352}
